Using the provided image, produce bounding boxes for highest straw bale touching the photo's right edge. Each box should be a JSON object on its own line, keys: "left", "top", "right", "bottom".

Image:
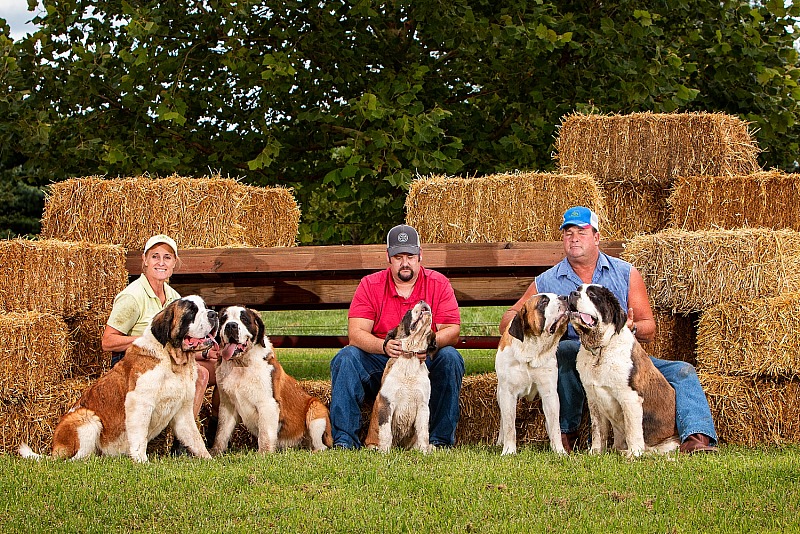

{"left": 668, "top": 171, "right": 800, "bottom": 231}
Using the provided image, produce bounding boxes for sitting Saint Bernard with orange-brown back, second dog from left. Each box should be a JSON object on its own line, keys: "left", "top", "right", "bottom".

{"left": 211, "top": 306, "right": 333, "bottom": 455}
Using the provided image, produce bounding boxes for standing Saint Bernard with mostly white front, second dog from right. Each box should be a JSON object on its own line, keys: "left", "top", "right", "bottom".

{"left": 494, "top": 293, "right": 569, "bottom": 454}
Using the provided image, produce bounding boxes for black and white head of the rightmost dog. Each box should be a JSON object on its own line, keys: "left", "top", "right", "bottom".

{"left": 569, "top": 284, "right": 628, "bottom": 347}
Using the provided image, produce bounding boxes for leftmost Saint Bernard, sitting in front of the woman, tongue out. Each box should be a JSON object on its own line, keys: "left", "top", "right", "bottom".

{"left": 19, "top": 295, "right": 218, "bottom": 462}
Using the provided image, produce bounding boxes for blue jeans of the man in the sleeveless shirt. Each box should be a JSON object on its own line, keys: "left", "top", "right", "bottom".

{"left": 556, "top": 339, "right": 717, "bottom": 445}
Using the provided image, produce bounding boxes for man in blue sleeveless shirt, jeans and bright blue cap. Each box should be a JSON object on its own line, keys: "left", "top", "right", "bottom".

{"left": 500, "top": 206, "right": 717, "bottom": 453}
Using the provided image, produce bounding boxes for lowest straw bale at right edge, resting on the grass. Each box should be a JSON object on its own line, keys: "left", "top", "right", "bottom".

{"left": 698, "top": 370, "right": 800, "bottom": 447}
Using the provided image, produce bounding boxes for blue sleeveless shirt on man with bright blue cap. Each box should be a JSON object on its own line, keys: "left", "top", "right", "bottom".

{"left": 536, "top": 252, "right": 632, "bottom": 340}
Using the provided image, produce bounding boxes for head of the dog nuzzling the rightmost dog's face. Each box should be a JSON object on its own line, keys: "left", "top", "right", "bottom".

{"left": 508, "top": 293, "right": 569, "bottom": 341}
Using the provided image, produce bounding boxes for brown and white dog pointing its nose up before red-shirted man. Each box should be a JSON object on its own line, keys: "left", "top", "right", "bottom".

{"left": 364, "top": 300, "right": 436, "bottom": 453}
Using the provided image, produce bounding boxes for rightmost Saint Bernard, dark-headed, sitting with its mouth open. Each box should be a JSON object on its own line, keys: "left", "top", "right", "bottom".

{"left": 569, "top": 284, "right": 680, "bottom": 457}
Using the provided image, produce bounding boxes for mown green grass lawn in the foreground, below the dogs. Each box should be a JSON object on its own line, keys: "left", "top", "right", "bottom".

{"left": 0, "top": 446, "right": 800, "bottom": 534}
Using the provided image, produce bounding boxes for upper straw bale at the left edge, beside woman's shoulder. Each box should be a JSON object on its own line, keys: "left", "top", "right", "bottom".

{"left": 0, "top": 239, "right": 128, "bottom": 317}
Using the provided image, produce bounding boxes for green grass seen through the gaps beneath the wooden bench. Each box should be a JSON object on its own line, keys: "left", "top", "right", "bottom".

{"left": 261, "top": 306, "right": 507, "bottom": 380}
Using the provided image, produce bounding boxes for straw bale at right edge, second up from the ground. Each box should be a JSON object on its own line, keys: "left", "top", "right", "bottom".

{"left": 697, "top": 293, "right": 800, "bottom": 378}
